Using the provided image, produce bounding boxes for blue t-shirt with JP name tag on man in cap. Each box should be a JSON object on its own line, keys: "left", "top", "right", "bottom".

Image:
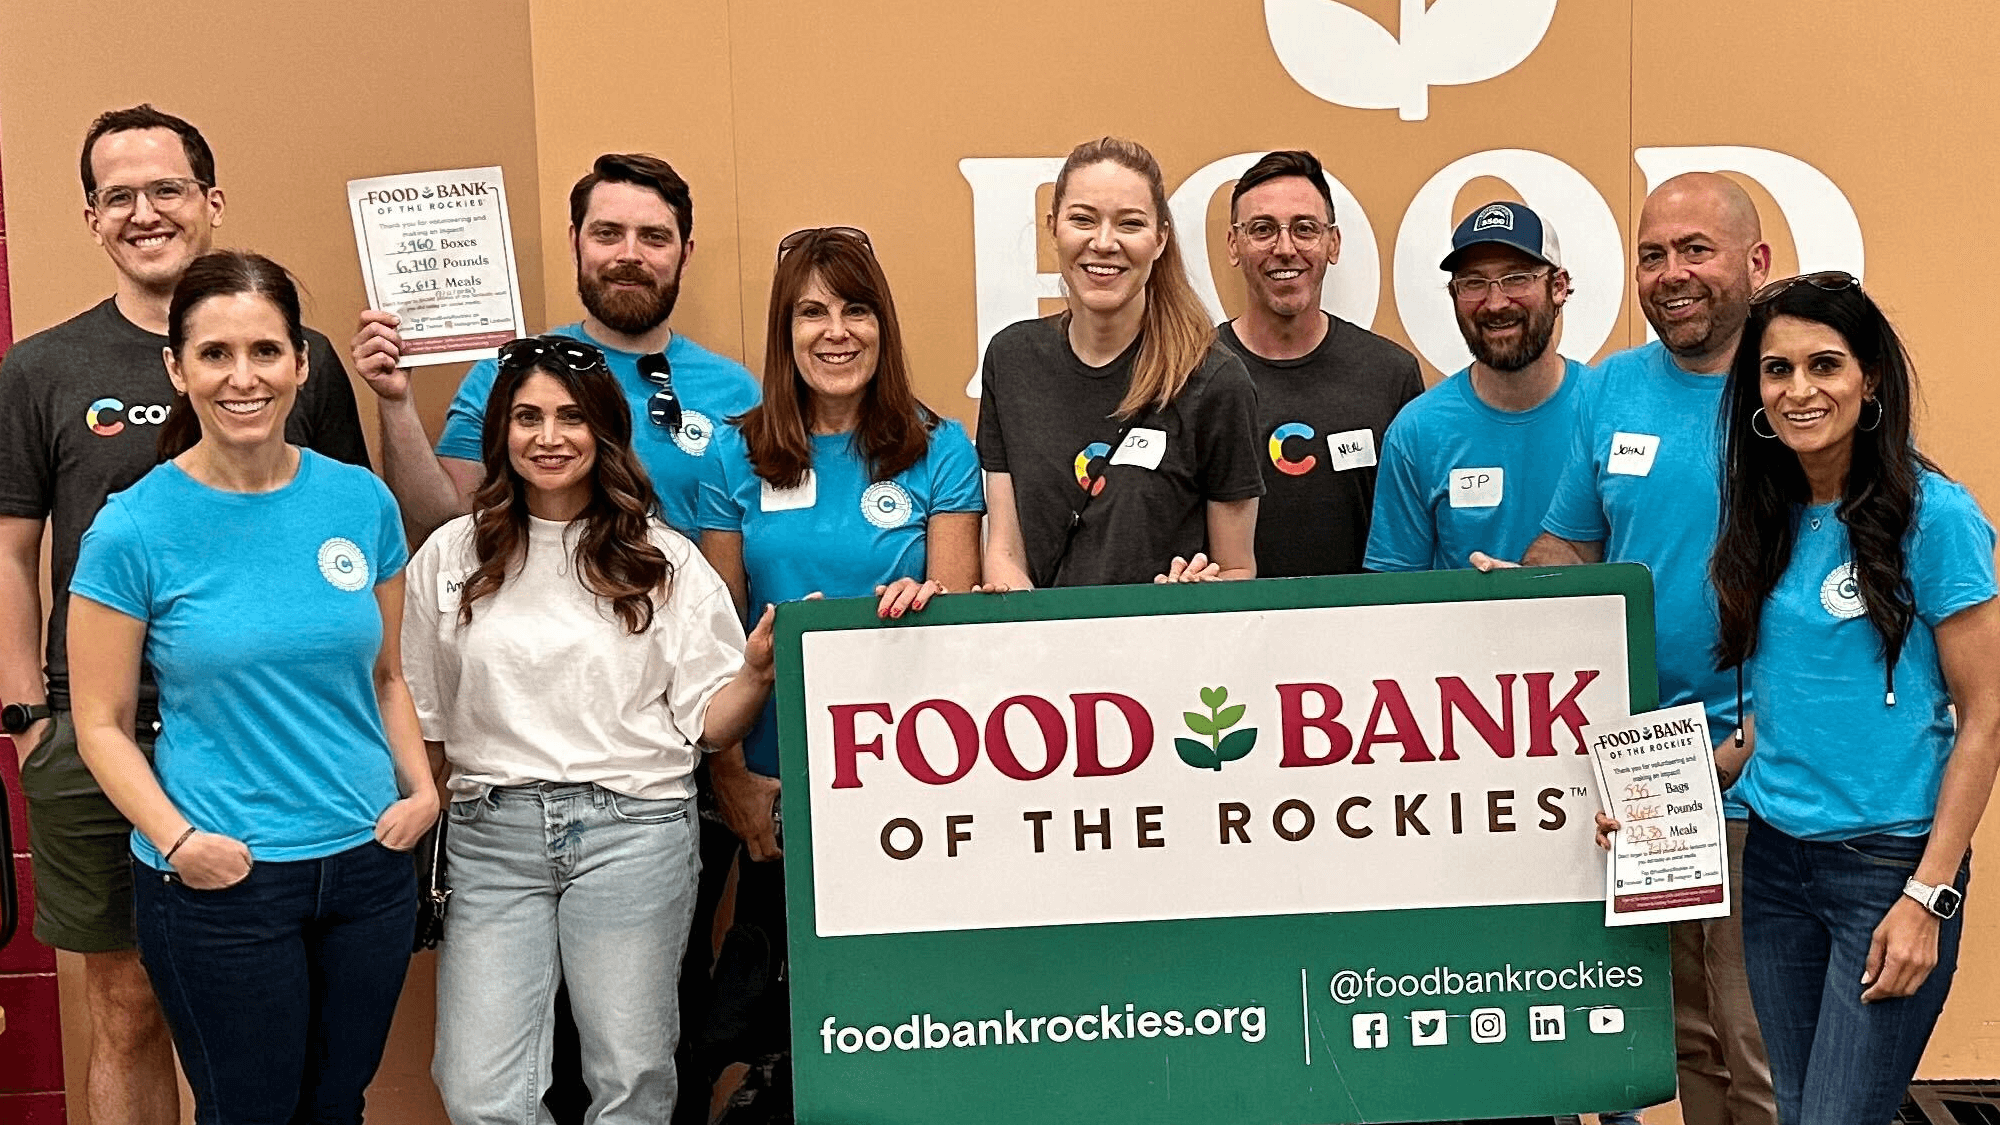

{"left": 1364, "top": 360, "right": 1590, "bottom": 571}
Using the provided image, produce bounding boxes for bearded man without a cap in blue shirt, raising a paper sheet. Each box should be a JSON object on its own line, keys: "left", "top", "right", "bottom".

{"left": 352, "top": 154, "right": 758, "bottom": 546}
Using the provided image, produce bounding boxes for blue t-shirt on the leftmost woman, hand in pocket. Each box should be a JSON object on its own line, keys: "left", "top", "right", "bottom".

{"left": 70, "top": 450, "right": 410, "bottom": 869}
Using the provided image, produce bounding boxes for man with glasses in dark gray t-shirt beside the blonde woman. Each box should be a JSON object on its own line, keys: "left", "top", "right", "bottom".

{"left": 1216, "top": 152, "right": 1424, "bottom": 579}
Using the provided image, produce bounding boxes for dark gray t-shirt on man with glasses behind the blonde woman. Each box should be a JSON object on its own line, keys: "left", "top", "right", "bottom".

{"left": 1216, "top": 316, "right": 1424, "bottom": 579}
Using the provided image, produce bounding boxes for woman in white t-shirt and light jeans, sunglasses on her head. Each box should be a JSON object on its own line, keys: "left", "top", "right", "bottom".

{"left": 404, "top": 336, "right": 772, "bottom": 1125}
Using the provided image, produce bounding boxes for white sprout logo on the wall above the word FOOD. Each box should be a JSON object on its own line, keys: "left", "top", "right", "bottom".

{"left": 1264, "top": 0, "right": 1556, "bottom": 120}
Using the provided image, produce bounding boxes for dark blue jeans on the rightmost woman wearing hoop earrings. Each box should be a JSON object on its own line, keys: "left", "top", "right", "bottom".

{"left": 1744, "top": 817, "right": 1972, "bottom": 1125}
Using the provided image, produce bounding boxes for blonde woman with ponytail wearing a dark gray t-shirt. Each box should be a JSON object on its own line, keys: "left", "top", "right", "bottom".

{"left": 980, "top": 136, "right": 1264, "bottom": 589}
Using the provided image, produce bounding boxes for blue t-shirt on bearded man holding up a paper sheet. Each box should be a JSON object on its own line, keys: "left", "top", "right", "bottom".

{"left": 438, "top": 324, "right": 762, "bottom": 536}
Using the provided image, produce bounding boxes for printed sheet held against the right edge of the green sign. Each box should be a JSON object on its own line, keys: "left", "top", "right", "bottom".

{"left": 1584, "top": 703, "right": 1730, "bottom": 925}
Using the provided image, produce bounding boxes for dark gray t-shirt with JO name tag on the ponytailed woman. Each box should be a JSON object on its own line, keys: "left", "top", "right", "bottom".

{"left": 978, "top": 316, "right": 1264, "bottom": 587}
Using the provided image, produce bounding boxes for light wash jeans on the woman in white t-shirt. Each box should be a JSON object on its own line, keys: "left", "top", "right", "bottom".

{"left": 430, "top": 783, "right": 700, "bottom": 1125}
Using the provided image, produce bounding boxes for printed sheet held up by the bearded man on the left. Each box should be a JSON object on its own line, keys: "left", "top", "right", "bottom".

{"left": 348, "top": 168, "right": 524, "bottom": 366}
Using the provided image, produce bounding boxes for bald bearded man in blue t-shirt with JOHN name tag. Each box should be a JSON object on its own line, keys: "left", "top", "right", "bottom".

{"left": 1522, "top": 172, "right": 1778, "bottom": 1125}
